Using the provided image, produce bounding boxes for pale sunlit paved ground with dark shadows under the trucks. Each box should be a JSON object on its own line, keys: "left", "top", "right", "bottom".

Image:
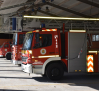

{"left": 0, "top": 58, "right": 99, "bottom": 91}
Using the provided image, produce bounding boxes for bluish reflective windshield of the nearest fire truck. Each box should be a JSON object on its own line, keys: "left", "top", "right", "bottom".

{"left": 22, "top": 33, "right": 33, "bottom": 50}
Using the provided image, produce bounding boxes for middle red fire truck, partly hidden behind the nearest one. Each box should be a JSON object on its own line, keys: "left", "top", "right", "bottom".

{"left": 11, "top": 32, "right": 26, "bottom": 65}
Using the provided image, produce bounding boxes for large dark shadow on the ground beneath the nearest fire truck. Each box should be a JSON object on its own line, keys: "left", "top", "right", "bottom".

{"left": 33, "top": 73, "right": 99, "bottom": 90}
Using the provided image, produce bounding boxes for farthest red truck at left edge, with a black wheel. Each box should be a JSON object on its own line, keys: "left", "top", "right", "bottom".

{"left": 0, "top": 42, "right": 11, "bottom": 60}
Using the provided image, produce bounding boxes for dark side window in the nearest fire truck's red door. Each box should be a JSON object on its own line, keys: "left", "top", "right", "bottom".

{"left": 35, "top": 33, "right": 52, "bottom": 48}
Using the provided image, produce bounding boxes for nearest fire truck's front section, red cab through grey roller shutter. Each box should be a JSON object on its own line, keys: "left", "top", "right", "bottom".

{"left": 21, "top": 29, "right": 87, "bottom": 80}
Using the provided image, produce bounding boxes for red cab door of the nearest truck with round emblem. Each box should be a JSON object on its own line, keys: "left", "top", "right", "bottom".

{"left": 33, "top": 32, "right": 55, "bottom": 65}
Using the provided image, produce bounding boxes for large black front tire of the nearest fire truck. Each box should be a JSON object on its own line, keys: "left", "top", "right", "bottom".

{"left": 46, "top": 63, "right": 64, "bottom": 80}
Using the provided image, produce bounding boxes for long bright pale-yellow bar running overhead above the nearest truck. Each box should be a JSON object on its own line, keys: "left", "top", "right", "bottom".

{"left": 24, "top": 16, "right": 99, "bottom": 21}
